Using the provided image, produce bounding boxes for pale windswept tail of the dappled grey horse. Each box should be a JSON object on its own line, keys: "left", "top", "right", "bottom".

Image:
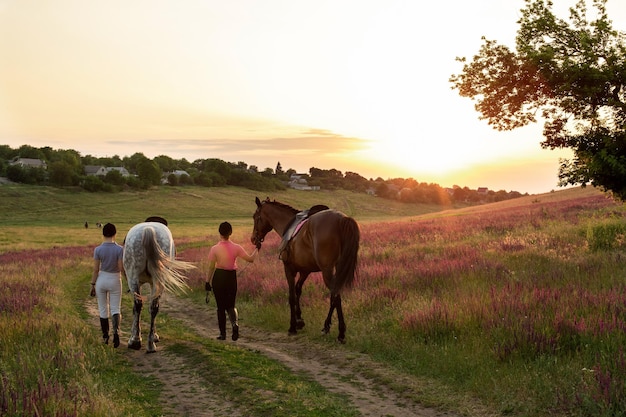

{"left": 142, "top": 227, "right": 195, "bottom": 292}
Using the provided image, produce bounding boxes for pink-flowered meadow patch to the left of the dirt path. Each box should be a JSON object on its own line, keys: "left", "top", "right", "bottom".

{"left": 0, "top": 247, "right": 107, "bottom": 416}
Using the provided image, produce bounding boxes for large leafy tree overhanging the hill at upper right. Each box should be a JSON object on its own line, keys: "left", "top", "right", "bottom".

{"left": 450, "top": 0, "right": 626, "bottom": 200}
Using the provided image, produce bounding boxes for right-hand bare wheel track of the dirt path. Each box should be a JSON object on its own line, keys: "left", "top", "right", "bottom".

{"left": 161, "top": 294, "right": 455, "bottom": 417}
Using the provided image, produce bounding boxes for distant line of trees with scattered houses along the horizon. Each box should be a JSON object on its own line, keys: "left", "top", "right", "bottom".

{"left": 0, "top": 145, "right": 522, "bottom": 205}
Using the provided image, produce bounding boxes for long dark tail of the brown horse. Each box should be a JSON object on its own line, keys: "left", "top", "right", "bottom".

{"left": 334, "top": 217, "right": 361, "bottom": 293}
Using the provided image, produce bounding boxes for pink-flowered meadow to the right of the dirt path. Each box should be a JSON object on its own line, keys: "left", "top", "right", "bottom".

{"left": 182, "top": 196, "right": 626, "bottom": 415}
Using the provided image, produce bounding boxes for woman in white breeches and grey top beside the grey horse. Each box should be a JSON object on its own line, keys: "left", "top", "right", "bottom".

{"left": 90, "top": 223, "right": 124, "bottom": 347}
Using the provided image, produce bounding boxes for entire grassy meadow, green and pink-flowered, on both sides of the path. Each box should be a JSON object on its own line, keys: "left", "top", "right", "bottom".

{"left": 0, "top": 187, "right": 626, "bottom": 416}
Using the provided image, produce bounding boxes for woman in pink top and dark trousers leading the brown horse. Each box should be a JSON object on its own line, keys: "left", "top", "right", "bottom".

{"left": 205, "top": 222, "right": 258, "bottom": 340}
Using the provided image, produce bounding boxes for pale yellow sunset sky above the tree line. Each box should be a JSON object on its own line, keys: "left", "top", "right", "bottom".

{"left": 0, "top": 0, "right": 626, "bottom": 193}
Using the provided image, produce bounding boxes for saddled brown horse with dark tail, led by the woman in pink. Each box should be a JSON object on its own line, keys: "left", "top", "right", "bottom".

{"left": 250, "top": 197, "right": 360, "bottom": 343}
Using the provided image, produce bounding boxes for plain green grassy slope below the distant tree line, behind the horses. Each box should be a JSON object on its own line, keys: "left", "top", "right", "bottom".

{"left": 0, "top": 185, "right": 442, "bottom": 253}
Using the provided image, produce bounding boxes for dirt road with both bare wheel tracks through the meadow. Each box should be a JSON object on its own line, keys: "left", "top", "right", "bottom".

{"left": 88, "top": 294, "right": 464, "bottom": 417}
